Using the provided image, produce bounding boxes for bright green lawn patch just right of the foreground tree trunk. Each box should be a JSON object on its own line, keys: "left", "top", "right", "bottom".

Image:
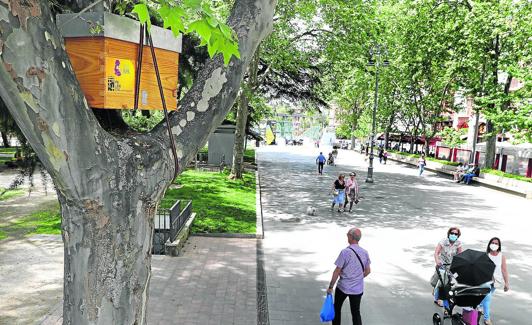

{"left": 163, "top": 170, "right": 256, "bottom": 234}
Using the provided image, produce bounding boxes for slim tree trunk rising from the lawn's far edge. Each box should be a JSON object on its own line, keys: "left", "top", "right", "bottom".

{"left": 229, "top": 89, "right": 249, "bottom": 179}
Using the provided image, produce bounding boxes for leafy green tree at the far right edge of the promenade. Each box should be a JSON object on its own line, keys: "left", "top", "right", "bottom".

{"left": 457, "top": 0, "right": 532, "bottom": 168}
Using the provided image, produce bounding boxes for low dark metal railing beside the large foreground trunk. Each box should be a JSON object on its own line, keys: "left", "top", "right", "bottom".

{"left": 152, "top": 200, "right": 192, "bottom": 255}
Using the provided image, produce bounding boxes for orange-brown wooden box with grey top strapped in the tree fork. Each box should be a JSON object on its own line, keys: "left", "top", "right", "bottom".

{"left": 57, "top": 12, "right": 181, "bottom": 110}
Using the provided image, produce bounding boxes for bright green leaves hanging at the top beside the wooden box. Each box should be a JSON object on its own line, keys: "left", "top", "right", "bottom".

{"left": 132, "top": 0, "right": 240, "bottom": 65}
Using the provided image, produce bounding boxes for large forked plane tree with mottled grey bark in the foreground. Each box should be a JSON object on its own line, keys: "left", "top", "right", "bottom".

{"left": 0, "top": 0, "right": 276, "bottom": 325}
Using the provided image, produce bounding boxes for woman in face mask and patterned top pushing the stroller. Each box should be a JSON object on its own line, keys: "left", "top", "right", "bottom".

{"left": 431, "top": 227, "right": 462, "bottom": 306}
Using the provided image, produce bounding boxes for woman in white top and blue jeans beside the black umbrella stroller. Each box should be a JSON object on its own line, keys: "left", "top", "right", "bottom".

{"left": 482, "top": 237, "right": 510, "bottom": 325}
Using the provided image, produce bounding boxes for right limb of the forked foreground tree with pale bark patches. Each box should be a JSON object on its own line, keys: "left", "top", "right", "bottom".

{"left": 151, "top": 0, "right": 277, "bottom": 182}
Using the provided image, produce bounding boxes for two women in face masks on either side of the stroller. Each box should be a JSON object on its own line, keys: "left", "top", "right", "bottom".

{"left": 431, "top": 227, "right": 510, "bottom": 325}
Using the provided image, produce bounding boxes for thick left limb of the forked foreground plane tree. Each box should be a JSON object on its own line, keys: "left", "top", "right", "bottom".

{"left": 0, "top": 1, "right": 112, "bottom": 194}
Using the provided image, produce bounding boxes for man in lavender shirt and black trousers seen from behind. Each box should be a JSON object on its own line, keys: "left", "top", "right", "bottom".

{"left": 327, "top": 228, "right": 371, "bottom": 325}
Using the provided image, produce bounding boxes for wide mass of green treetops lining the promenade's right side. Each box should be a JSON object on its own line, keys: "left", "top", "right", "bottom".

{"left": 318, "top": 0, "right": 532, "bottom": 148}
